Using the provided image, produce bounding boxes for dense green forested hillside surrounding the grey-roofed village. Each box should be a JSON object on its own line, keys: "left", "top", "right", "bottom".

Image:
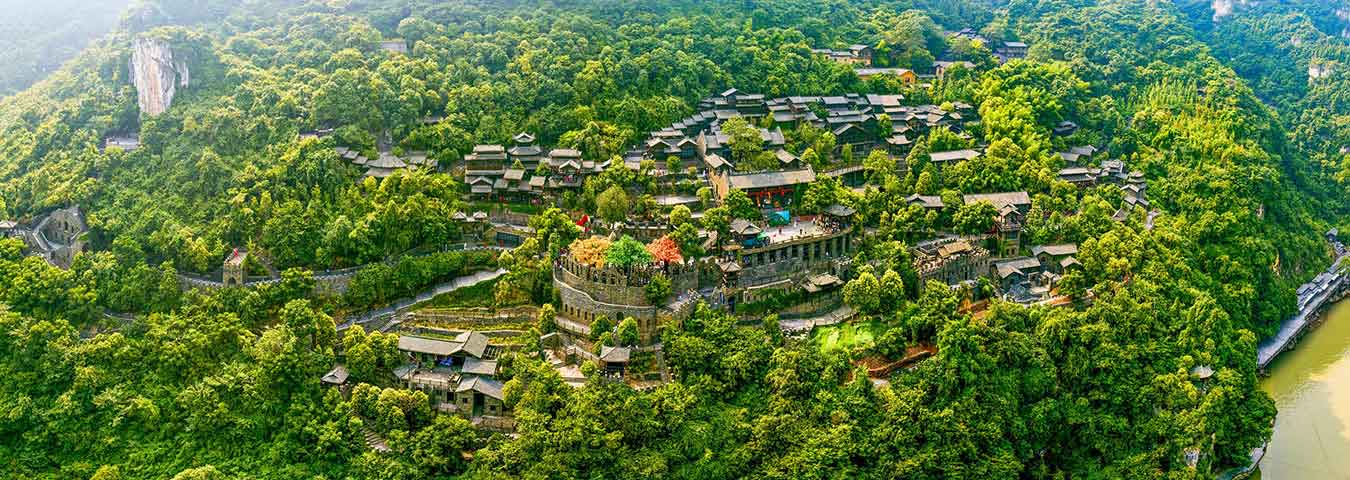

{"left": 0, "top": 0, "right": 1350, "bottom": 479}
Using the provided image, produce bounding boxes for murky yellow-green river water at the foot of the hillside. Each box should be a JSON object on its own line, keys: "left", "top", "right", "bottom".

{"left": 1261, "top": 301, "right": 1350, "bottom": 480}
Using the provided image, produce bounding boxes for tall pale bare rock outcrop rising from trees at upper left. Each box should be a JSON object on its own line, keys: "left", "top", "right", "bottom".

{"left": 131, "top": 38, "right": 192, "bottom": 115}
